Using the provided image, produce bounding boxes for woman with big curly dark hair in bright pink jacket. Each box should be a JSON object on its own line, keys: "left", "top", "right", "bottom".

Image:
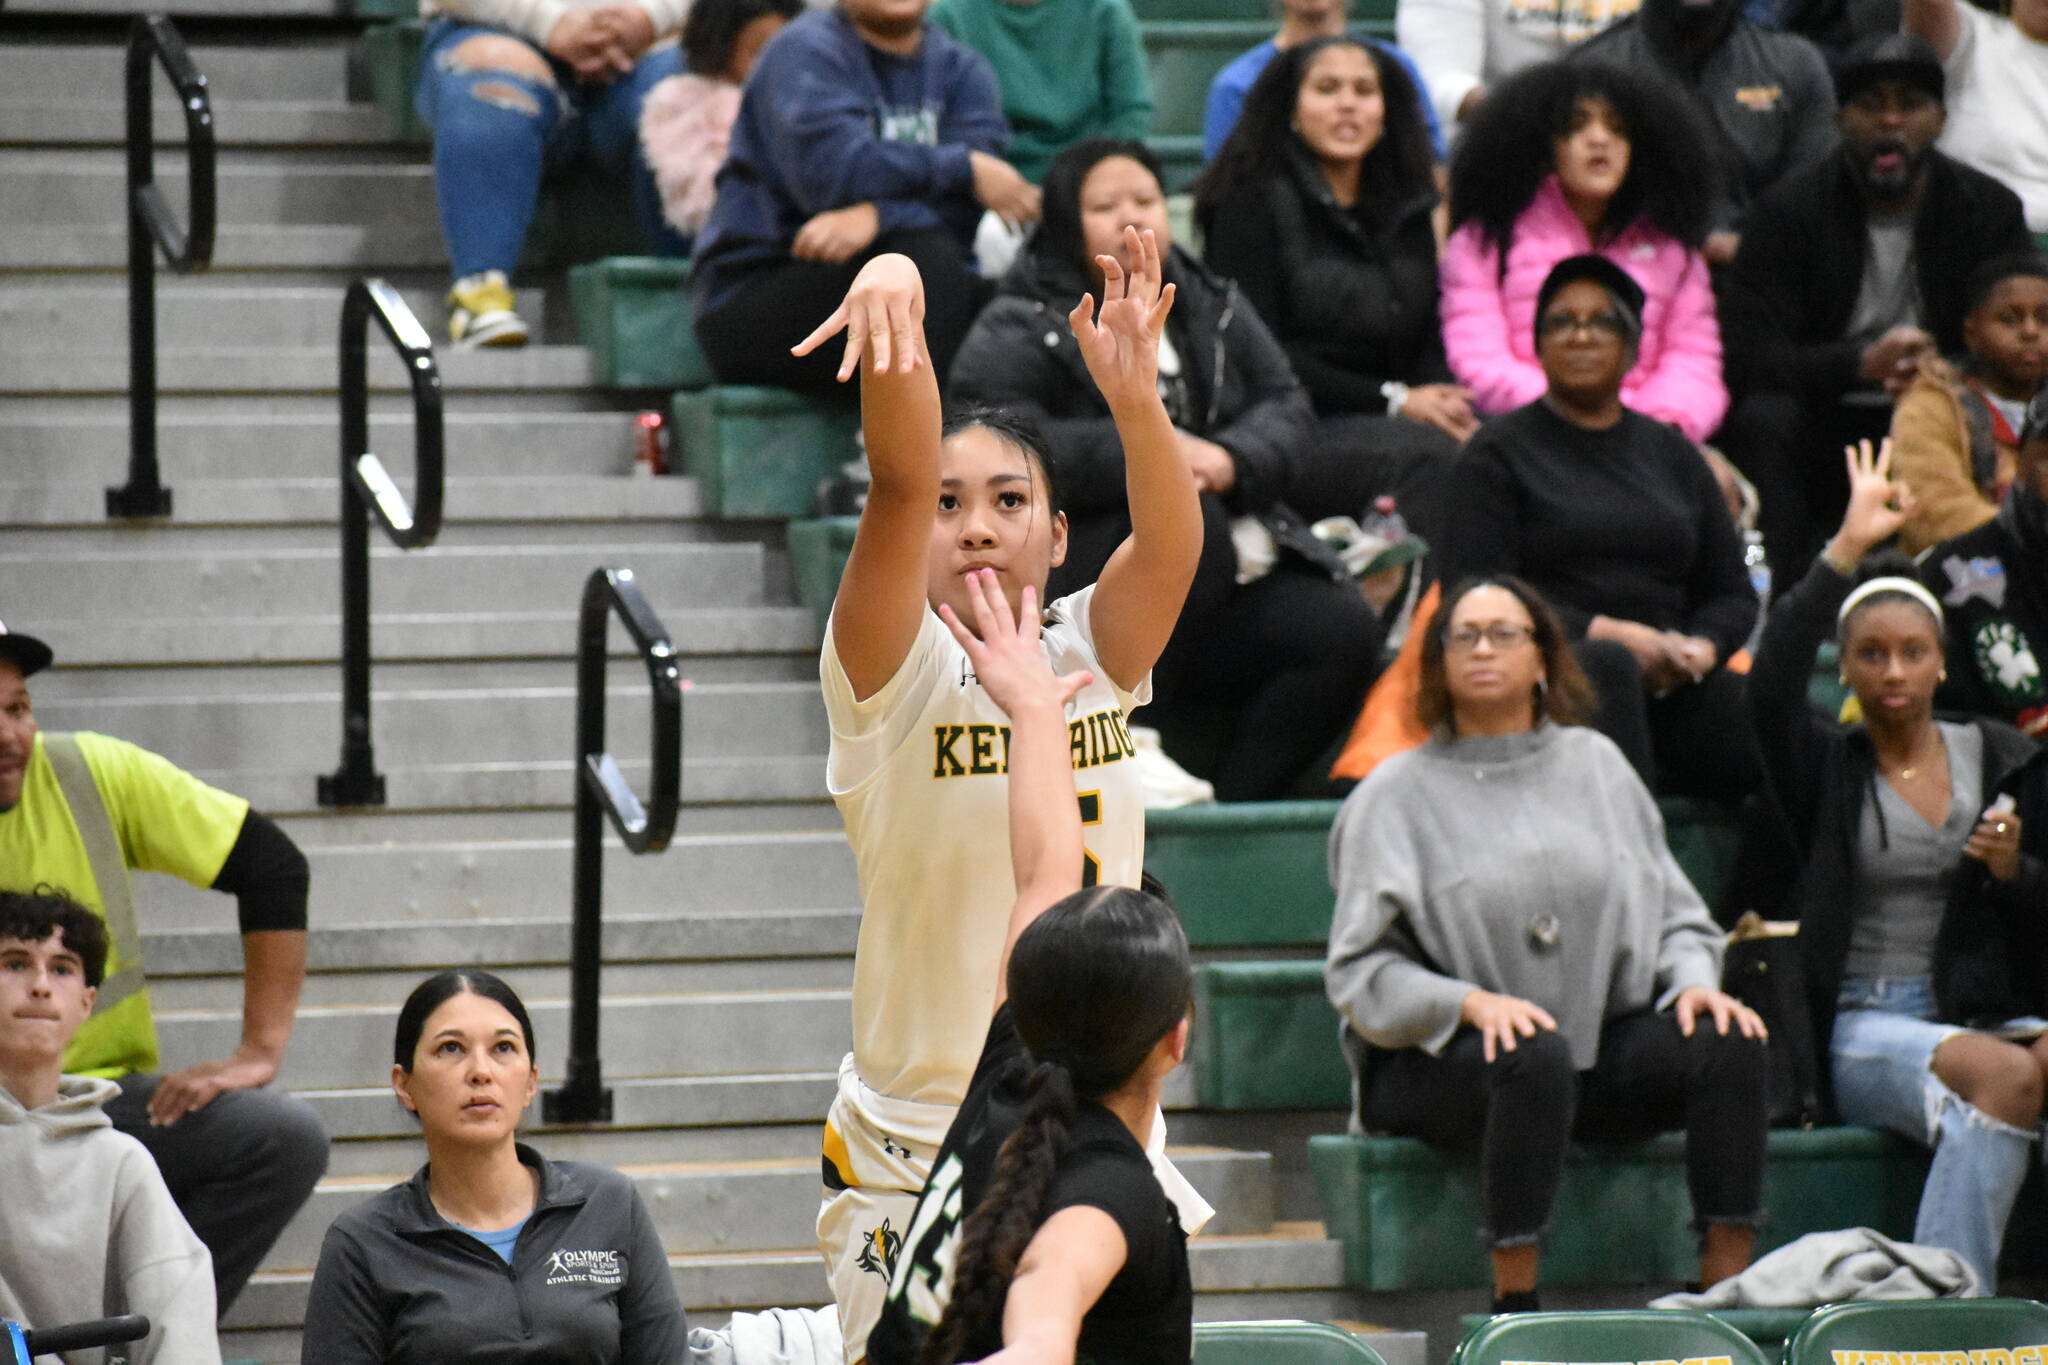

{"left": 1440, "top": 61, "right": 1729, "bottom": 444}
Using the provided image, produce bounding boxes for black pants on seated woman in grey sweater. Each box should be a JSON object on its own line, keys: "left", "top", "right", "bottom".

{"left": 1358, "top": 1009, "right": 1769, "bottom": 1246}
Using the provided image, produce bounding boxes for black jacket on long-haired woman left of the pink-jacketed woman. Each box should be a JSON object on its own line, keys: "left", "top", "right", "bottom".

{"left": 1198, "top": 145, "right": 1450, "bottom": 417}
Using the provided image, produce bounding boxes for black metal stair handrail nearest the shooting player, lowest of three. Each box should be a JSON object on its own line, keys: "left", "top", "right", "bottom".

{"left": 541, "top": 569, "right": 682, "bottom": 1124}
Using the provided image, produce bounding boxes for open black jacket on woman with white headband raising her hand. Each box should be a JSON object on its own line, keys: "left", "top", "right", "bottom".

{"left": 1749, "top": 559, "right": 2048, "bottom": 1105}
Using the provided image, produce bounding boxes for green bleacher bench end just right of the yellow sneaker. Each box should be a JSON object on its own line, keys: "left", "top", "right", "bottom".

{"left": 569, "top": 256, "right": 719, "bottom": 389}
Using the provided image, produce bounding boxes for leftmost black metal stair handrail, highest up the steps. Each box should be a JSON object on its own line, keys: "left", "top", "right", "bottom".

{"left": 106, "top": 14, "right": 215, "bottom": 516}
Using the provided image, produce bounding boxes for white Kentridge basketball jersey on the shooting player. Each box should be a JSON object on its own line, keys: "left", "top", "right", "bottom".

{"left": 819, "top": 587, "right": 1151, "bottom": 1105}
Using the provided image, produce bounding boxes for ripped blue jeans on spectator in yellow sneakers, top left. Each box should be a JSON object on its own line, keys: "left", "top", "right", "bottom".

{"left": 416, "top": 18, "right": 684, "bottom": 278}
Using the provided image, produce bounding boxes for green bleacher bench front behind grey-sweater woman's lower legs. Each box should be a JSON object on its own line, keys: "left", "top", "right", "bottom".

{"left": 1309, "top": 1128, "right": 1927, "bottom": 1289}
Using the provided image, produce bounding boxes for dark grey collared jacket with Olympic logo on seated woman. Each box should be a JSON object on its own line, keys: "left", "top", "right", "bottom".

{"left": 305, "top": 1146, "right": 688, "bottom": 1365}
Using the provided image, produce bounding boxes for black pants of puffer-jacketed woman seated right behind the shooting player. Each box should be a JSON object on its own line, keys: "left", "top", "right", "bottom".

{"left": 1049, "top": 493, "right": 1380, "bottom": 800}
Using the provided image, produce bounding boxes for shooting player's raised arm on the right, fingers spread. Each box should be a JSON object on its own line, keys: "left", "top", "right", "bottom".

{"left": 1067, "top": 227, "right": 1202, "bottom": 692}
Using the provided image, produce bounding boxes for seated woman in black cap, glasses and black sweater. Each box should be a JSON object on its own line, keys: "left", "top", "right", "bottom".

{"left": 1442, "top": 256, "right": 1761, "bottom": 800}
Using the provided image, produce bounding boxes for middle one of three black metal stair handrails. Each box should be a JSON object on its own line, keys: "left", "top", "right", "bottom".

{"left": 317, "top": 280, "right": 446, "bottom": 806}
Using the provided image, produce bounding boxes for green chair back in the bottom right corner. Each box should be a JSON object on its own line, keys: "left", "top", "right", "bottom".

{"left": 1786, "top": 1300, "right": 2048, "bottom": 1365}
